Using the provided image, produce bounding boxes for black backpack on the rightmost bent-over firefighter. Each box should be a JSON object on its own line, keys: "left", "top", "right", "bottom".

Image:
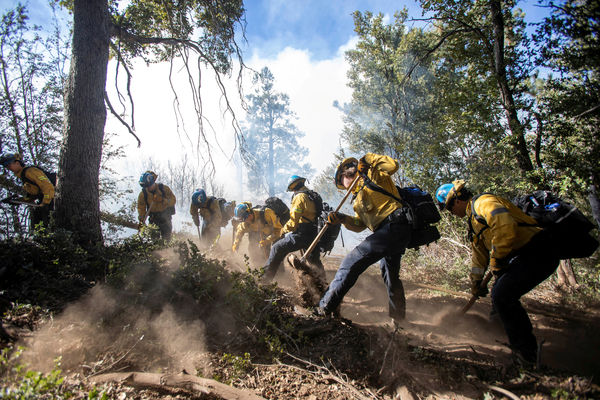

{"left": 512, "top": 190, "right": 598, "bottom": 260}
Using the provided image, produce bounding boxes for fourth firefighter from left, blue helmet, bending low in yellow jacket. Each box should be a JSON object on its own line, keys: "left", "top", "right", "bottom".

{"left": 231, "top": 202, "right": 281, "bottom": 261}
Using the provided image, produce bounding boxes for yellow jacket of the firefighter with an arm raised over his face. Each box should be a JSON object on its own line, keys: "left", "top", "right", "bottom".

{"left": 343, "top": 153, "right": 403, "bottom": 232}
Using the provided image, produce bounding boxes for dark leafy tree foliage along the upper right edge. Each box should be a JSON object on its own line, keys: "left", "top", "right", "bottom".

{"left": 536, "top": 0, "right": 600, "bottom": 195}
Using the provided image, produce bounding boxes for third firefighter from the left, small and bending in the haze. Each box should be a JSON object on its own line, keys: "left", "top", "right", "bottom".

{"left": 190, "top": 189, "right": 223, "bottom": 246}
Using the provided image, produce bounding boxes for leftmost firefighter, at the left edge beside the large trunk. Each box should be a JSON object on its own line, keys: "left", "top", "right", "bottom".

{"left": 0, "top": 153, "right": 56, "bottom": 228}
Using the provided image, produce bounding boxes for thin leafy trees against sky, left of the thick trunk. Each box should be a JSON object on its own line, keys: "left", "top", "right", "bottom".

{"left": 0, "top": 5, "right": 68, "bottom": 238}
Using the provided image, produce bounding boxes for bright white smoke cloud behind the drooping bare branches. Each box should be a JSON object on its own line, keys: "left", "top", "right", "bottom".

{"left": 107, "top": 39, "right": 354, "bottom": 197}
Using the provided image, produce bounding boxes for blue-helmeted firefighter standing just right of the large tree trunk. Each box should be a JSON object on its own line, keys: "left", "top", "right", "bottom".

{"left": 137, "top": 171, "right": 176, "bottom": 240}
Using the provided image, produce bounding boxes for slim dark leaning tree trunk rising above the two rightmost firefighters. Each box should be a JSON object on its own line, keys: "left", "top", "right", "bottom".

{"left": 490, "top": 0, "right": 533, "bottom": 172}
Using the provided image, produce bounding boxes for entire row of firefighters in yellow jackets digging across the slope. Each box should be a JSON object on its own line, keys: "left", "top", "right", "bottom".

{"left": 0, "top": 153, "right": 580, "bottom": 365}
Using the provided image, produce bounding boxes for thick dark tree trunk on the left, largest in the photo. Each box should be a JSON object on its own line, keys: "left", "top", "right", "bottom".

{"left": 54, "top": 0, "right": 110, "bottom": 246}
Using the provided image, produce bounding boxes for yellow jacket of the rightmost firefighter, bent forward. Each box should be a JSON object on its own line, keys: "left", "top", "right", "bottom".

{"left": 466, "top": 194, "right": 541, "bottom": 280}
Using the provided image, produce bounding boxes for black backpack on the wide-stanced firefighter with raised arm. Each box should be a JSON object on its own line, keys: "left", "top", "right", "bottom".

{"left": 365, "top": 179, "right": 442, "bottom": 249}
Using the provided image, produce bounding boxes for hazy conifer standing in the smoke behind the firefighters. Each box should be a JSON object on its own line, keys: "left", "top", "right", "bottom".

{"left": 244, "top": 67, "right": 312, "bottom": 196}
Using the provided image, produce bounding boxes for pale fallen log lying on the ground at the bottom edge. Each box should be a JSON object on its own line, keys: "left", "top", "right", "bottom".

{"left": 90, "top": 372, "right": 265, "bottom": 400}
